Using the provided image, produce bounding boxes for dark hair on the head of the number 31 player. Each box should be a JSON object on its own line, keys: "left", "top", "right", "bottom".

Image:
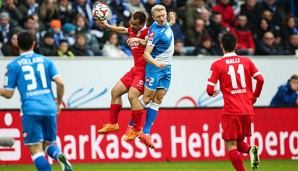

{"left": 18, "top": 30, "right": 34, "bottom": 50}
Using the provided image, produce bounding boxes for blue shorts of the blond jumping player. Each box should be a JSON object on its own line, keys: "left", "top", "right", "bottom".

{"left": 145, "top": 65, "right": 171, "bottom": 90}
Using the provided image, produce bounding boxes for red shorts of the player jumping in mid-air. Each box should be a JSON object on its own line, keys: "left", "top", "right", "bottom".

{"left": 120, "top": 67, "right": 145, "bottom": 94}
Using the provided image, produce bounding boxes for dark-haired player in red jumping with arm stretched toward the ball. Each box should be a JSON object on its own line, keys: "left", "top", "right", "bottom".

{"left": 98, "top": 11, "right": 175, "bottom": 141}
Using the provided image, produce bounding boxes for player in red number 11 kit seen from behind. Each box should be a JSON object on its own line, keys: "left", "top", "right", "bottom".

{"left": 207, "top": 33, "right": 264, "bottom": 171}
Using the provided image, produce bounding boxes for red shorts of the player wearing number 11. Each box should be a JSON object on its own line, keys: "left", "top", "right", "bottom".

{"left": 222, "top": 115, "right": 253, "bottom": 142}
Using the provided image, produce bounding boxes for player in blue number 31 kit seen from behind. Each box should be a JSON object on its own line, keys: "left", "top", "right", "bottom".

{"left": 0, "top": 31, "right": 72, "bottom": 171}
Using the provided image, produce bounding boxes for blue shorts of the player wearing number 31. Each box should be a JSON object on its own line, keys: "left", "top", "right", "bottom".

{"left": 22, "top": 115, "right": 57, "bottom": 145}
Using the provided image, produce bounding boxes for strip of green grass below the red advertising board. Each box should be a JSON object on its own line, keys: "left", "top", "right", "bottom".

{"left": 0, "top": 160, "right": 298, "bottom": 171}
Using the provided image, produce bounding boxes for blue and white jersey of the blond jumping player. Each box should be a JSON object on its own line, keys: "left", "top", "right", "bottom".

{"left": 147, "top": 22, "right": 174, "bottom": 65}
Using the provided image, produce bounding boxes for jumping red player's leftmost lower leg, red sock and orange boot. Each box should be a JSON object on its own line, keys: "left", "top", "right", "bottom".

{"left": 98, "top": 80, "right": 127, "bottom": 134}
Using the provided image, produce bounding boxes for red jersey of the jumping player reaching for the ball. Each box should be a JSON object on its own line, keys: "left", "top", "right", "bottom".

{"left": 127, "top": 26, "right": 150, "bottom": 67}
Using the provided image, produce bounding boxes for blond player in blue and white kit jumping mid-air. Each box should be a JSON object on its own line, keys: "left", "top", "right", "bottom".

{"left": 126, "top": 5, "right": 174, "bottom": 148}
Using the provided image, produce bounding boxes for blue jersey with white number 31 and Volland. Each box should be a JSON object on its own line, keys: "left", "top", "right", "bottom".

{"left": 4, "top": 52, "right": 59, "bottom": 115}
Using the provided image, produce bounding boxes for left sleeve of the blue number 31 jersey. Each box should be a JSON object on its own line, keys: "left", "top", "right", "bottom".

{"left": 4, "top": 64, "right": 17, "bottom": 90}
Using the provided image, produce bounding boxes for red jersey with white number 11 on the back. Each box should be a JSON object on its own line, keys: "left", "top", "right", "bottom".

{"left": 208, "top": 53, "right": 261, "bottom": 115}
